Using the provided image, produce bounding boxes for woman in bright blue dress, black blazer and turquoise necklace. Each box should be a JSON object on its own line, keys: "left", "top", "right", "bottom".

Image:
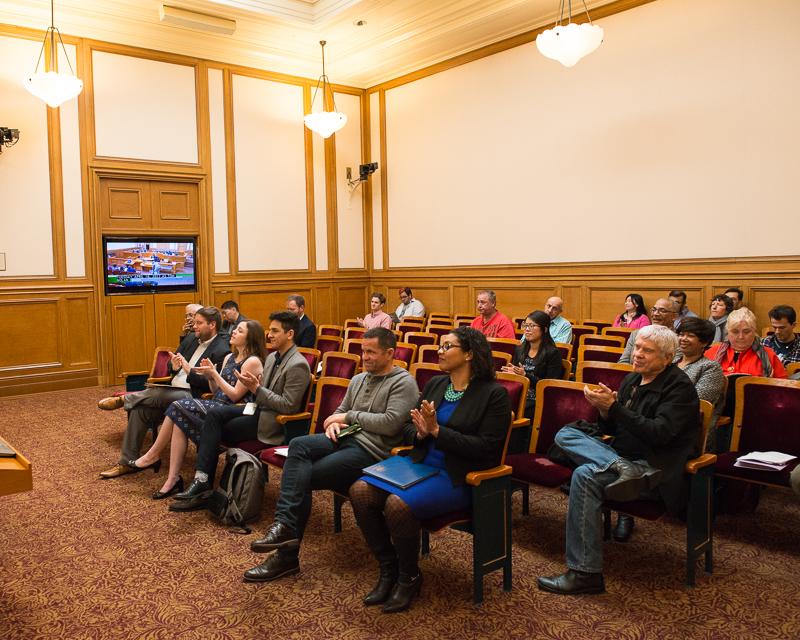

{"left": 350, "top": 327, "right": 511, "bottom": 613}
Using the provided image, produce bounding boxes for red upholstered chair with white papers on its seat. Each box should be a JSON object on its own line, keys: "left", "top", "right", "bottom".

{"left": 715, "top": 376, "right": 800, "bottom": 488}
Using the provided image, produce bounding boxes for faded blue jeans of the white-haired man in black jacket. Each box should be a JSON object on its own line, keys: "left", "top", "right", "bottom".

{"left": 555, "top": 427, "right": 647, "bottom": 573}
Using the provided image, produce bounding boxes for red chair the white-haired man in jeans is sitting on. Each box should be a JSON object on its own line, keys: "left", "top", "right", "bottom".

{"left": 603, "top": 400, "right": 716, "bottom": 587}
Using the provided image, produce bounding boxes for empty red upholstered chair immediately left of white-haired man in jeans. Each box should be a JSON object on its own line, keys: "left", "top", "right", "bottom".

{"left": 506, "top": 380, "right": 598, "bottom": 515}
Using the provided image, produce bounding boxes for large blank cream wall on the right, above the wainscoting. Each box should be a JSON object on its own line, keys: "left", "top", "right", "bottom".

{"left": 386, "top": 0, "right": 800, "bottom": 267}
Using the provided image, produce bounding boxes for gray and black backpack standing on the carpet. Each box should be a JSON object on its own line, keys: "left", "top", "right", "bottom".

{"left": 208, "top": 449, "right": 266, "bottom": 533}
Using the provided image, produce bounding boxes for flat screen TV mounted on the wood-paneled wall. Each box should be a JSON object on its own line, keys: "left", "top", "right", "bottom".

{"left": 103, "top": 236, "right": 197, "bottom": 295}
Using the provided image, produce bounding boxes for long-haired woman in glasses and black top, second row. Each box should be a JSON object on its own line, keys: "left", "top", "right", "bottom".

{"left": 503, "top": 311, "right": 564, "bottom": 419}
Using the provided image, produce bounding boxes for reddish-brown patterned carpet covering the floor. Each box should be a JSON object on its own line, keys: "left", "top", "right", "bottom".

{"left": 0, "top": 388, "right": 800, "bottom": 640}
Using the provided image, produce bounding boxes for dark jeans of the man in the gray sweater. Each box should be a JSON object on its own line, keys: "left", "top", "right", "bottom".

{"left": 275, "top": 434, "right": 376, "bottom": 551}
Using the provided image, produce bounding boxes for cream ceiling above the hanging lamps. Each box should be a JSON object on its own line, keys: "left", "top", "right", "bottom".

{"left": 0, "top": 0, "right": 624, "bottom": 88}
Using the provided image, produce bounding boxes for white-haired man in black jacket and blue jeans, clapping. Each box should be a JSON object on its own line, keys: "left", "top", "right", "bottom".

{"left": 537, "top": 325, "right": 700, "bottom": 594}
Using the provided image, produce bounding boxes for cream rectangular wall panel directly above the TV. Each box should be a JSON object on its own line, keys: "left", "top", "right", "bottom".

{"left": 92, "top": 51, "right": 197, "bottom": 163}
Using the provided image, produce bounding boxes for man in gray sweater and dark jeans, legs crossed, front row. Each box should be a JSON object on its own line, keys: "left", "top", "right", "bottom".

{"left": 244, "top": 327, "right": 419, "bottom": 582}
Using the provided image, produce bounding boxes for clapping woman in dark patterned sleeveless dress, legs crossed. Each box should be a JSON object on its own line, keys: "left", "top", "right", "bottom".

{"left": 128, "top": 320, "right": 267, "bottom": 500}
